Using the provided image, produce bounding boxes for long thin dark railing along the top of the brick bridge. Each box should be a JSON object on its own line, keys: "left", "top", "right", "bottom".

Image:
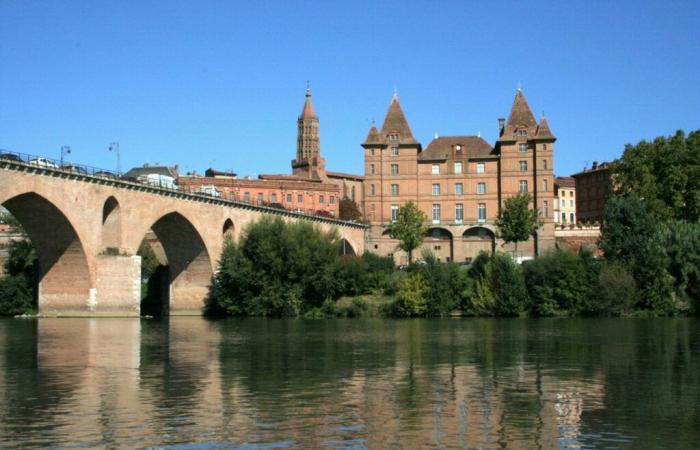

{"left": 0, "top": 149, "right": 350, "bottom": 224}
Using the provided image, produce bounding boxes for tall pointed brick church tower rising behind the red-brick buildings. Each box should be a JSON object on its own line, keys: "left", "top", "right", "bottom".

{"left": 292, "top": 87, "right": 325, "bottom": 178}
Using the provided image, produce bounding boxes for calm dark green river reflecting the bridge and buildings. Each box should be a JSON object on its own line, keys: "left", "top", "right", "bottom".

{"left": 0, "top": 317, "right": 700, "bottom": 449}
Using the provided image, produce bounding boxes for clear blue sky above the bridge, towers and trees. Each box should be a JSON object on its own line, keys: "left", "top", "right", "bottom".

{"left": 0, "top": 0, "right": 700, "bottom": 175}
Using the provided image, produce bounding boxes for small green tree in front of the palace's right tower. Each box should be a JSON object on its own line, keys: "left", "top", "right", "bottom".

{"left": 496, "top": 192, "right": 540, "bottom": 255}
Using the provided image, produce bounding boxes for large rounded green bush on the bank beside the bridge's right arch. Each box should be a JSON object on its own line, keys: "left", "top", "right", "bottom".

{"left": 207, "top": 217, "right": 340, "bottom": 316}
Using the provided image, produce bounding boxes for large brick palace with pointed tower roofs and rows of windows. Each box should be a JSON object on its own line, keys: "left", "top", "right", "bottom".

{"left": 362, "top": 90, "right": 556, "bottom": 264}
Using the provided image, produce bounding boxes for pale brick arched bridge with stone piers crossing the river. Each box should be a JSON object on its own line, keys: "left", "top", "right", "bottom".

{"left": 0, "top": 159, "right": 365, "bottom": 316}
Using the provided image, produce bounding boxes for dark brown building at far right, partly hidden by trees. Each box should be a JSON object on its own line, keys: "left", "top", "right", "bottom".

{"left": 573, "top": 162, "right": 613, "bottom": 223}
